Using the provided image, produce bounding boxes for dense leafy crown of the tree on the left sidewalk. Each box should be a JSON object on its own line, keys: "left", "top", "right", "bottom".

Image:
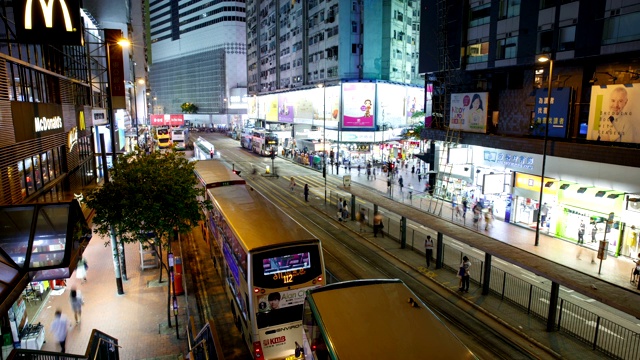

{"left": 86, "top": 149, "right": 211, "bottom": 245}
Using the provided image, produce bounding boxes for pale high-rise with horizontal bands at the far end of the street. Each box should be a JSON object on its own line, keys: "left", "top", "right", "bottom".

{"left": 148, "top": 0, "right": 247, "bottom": 125}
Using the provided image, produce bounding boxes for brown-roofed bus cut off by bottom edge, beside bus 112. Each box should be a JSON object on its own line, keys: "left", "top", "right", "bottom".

{"left": 297, "top": 279, "right": 477, "bottom": 360}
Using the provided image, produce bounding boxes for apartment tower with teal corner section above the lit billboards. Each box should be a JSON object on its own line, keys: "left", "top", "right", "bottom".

{"left": 247, "top": 0, "right": 422, "bottom": 94}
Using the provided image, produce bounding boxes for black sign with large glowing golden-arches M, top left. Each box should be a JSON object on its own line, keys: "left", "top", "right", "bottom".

{"left": 13, "top": 0, "right": 83, "bottom": 45}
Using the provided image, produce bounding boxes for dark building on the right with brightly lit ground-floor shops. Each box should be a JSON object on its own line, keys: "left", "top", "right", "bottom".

{"left": 420, "top": 0, "right": 640, "bottom": 256}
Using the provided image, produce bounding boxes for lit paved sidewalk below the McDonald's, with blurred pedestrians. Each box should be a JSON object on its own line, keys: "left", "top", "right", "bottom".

{"left": 29, "top": 234, "right": 191, "bottom": 359}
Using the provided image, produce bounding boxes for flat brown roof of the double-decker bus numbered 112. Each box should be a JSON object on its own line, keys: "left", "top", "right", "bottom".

{"left": 208, "top": 181, "right": 316, "bottom": 251}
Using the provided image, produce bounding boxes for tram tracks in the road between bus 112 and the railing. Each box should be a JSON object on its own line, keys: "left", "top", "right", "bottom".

{"left": 209, "top": 136, "right": 557, "bottom": 359}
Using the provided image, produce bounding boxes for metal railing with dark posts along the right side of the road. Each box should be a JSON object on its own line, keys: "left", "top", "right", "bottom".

{"left": 328, "top": 191, "right": 640, "bottom": 360}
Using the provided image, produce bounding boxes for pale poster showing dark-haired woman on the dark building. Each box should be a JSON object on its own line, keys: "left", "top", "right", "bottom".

{"left": 449, "top": 92, "right": 489, "bottom": 133}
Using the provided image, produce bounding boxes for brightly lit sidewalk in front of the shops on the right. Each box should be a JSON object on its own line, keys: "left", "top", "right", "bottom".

{"left": 327, "top": 160, "right": 637, "bottom": 290}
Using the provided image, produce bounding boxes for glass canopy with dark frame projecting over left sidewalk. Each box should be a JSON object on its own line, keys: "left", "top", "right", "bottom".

{"left": 0, "top": 200, "right": 91, "bottom": 313}
